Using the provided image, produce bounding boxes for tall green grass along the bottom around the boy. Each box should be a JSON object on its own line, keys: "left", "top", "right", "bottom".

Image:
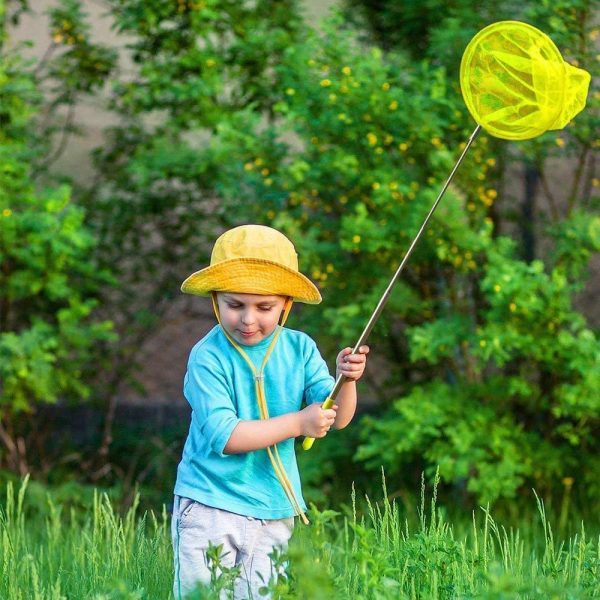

{"left": 0, "top": 481, "right": 600, "bottom": 600}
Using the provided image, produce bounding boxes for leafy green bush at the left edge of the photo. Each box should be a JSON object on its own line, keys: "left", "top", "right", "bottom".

{"left": 0, "top": 43, "right": 112, "bottom": 474}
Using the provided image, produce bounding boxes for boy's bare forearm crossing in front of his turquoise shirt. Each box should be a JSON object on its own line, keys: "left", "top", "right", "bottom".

{"left": 223, "top": 412, "right": 302, "bottom": 454}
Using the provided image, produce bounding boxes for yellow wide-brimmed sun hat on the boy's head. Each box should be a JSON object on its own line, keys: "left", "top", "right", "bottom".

{"left": 181, "top": 225, "right": 321, "bottom": 304}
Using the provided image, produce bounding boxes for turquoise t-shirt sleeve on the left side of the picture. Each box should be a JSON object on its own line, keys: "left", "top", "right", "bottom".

{"left": 183, "top": 352, "right": 241, "bottom": 457}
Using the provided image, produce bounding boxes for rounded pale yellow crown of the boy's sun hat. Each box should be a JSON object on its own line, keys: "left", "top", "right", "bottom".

{"left": 210, "top": 225, "right": 298, "bottom": 271}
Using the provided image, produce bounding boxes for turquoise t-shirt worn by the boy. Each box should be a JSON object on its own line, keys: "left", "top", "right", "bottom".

{"left": 175, "top": 325, "right": 334, "bottom": 519}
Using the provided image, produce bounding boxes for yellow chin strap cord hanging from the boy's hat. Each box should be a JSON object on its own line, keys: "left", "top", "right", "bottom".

{"left": 211, "top": 292, "right": 308, "bottom": 525}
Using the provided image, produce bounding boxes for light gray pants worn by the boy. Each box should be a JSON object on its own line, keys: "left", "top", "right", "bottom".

{"left": 171, "top": 496, "right": 294, "bottom": 600}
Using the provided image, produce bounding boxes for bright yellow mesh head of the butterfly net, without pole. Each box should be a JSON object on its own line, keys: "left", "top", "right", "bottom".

{"left": 460, "top": 21, "right": 590, "bottom": 140}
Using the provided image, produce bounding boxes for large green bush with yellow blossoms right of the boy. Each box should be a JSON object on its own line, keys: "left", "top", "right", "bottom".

{"left": 212, "top": 11, "right": 600, "bottom": 502}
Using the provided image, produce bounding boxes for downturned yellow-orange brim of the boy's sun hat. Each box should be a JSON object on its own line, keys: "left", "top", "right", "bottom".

{"left": 181, "top": 258, "right": 321, "bottom": 304}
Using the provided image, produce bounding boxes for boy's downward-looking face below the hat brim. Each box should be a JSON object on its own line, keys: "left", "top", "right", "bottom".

{"left": 217, "top": 292, "right": 285, "bottom": 346}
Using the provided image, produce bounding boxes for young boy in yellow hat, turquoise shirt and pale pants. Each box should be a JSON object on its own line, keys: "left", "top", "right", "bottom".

{"left": 172, "top": 225, "right": 369, "bottom": 599}
